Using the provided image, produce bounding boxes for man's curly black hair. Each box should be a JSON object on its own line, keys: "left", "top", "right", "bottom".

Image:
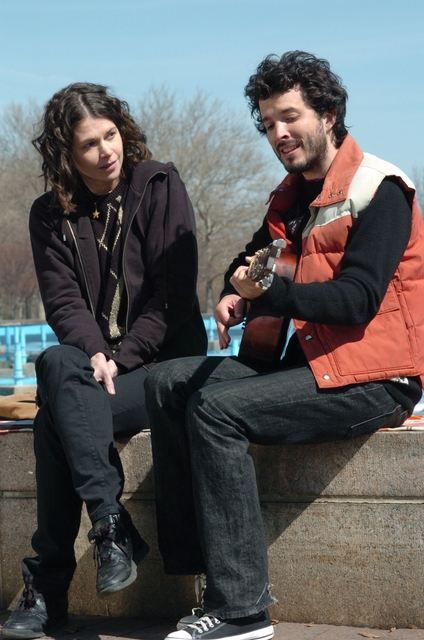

{"left": 244, "top": 51, "right": 348, "bottom": 148}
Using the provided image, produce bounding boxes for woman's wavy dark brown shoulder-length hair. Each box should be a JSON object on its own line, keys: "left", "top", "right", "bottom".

{"left": 32, "top": 82, "right": 152, "bottom": 215}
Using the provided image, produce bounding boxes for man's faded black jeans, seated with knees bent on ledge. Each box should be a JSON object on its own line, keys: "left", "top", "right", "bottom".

{"left": 146, "top": 357, "right": 407, "bottom": 618}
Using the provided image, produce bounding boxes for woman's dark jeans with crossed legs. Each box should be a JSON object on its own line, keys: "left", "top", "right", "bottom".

{"left": 23, "top": 346, "right": 148, "bottom": 597}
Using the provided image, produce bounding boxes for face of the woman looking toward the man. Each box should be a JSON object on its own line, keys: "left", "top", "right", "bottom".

{"left": 72, "top": 116, "right": 124, "bottom": 195}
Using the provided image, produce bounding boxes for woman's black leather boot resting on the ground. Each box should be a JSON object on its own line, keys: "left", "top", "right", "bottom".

{"left": 1, "top": 576, "right": 68, "bottom": 640}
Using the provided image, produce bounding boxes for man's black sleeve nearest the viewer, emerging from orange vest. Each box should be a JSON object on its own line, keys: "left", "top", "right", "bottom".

{"left": 252, "top": 178, "right": 412, "bottom": 325}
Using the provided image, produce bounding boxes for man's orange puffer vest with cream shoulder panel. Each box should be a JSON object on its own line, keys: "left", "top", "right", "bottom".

{"left": 267, "top": 135, "right": 424, "bottom": 388}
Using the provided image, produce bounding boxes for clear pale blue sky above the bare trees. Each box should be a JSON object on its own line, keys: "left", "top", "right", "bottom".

{"left": 0, "top": 0, "right": 424, "bottom": 173}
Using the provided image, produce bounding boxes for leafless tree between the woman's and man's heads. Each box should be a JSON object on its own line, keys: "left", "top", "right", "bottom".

{"left": 137, "top": 88, "right": 277, "bottom": 313}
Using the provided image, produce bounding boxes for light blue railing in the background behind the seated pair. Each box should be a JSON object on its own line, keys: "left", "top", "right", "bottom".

{"left": 0, "top": 316, "right": 241, "bottom": 386}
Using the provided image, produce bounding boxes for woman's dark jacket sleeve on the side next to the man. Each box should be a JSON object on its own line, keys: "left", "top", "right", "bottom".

{"left": 113, "top": 168, "right": 197, "bottom": 371}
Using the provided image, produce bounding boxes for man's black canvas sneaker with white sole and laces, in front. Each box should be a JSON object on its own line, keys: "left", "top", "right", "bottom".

{"left": 166, "top": 611, "right": 274, "bottom": 640}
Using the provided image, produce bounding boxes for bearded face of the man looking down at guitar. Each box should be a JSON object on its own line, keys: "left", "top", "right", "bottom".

{"left": 259, "top": 89, "right": 337, "bottom": 180}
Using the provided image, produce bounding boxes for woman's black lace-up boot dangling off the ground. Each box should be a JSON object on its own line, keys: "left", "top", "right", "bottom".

{"left": 88, "top": 514, "right": 149, "bottom": 598}
